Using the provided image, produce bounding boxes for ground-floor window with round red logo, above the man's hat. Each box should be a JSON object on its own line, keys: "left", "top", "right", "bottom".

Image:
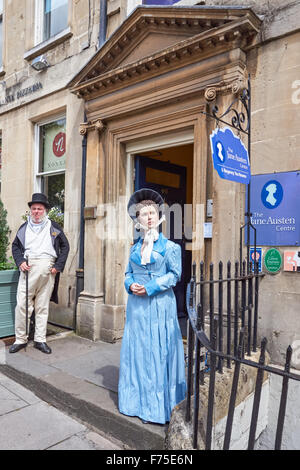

{"left": 36, "top": 117, "right": 66, "bottom": 212}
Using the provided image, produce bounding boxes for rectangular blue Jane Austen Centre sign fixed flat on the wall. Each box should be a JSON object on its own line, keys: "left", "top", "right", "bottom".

{"left": 245, "top": 171, "right": 300, "bottom": 246}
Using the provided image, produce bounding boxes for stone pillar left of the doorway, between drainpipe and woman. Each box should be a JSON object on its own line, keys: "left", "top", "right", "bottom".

{"left": 77, "top": 120, "right": 126, "bottom": 342}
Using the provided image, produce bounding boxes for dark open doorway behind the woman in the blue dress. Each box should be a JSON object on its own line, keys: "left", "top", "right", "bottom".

{"left": 134, "top": 144, "right": 193, "bottom": 337}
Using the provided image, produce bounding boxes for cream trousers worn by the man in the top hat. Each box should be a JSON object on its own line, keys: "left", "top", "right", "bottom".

{"left": 15, "top": 259, "right": 55, "bottom": 344}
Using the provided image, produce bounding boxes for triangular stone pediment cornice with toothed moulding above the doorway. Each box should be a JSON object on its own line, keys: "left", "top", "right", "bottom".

{"left": 70, "top": 8, "right": 260, "bottom": 100}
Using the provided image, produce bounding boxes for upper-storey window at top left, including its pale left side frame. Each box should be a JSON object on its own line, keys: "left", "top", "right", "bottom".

{"left": 35, "top": 0, "right": 68, "bottom": 44}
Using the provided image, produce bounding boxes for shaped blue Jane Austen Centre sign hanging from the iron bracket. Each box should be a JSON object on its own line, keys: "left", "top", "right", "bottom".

{"left": 210, "top": 127, "right": 251, "bottom": 184}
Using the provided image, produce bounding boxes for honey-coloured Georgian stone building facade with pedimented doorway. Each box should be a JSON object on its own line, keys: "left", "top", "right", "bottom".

{"left": 0, "top": 0, "right": 300, "bottom": 374}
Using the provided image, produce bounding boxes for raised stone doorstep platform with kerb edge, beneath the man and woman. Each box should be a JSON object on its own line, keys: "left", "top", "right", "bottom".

{"left": 0, "top": 335, "right": 166, "bottom": 449}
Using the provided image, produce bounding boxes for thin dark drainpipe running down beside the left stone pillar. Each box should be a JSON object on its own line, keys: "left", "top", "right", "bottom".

{"left": 73, "top": 113, "right": 87, "bottom": 331}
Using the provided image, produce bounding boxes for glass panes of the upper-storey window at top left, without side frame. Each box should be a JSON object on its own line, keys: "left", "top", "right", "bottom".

{"left": 43, "top": 0, "right": 68, "bottom": 41}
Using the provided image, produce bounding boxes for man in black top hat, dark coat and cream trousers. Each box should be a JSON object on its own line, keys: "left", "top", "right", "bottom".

{"left": 9, "top": 193, "right": 69, "bottom": 354}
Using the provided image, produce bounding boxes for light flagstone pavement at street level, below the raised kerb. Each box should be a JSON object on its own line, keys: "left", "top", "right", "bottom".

{"left": 0, "top": 373, "right": 122, "bottom": 450}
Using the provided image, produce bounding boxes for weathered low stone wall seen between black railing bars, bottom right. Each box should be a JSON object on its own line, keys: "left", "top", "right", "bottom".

{"left": 166, "top": 352, "right": 269, "bottom": 450}
